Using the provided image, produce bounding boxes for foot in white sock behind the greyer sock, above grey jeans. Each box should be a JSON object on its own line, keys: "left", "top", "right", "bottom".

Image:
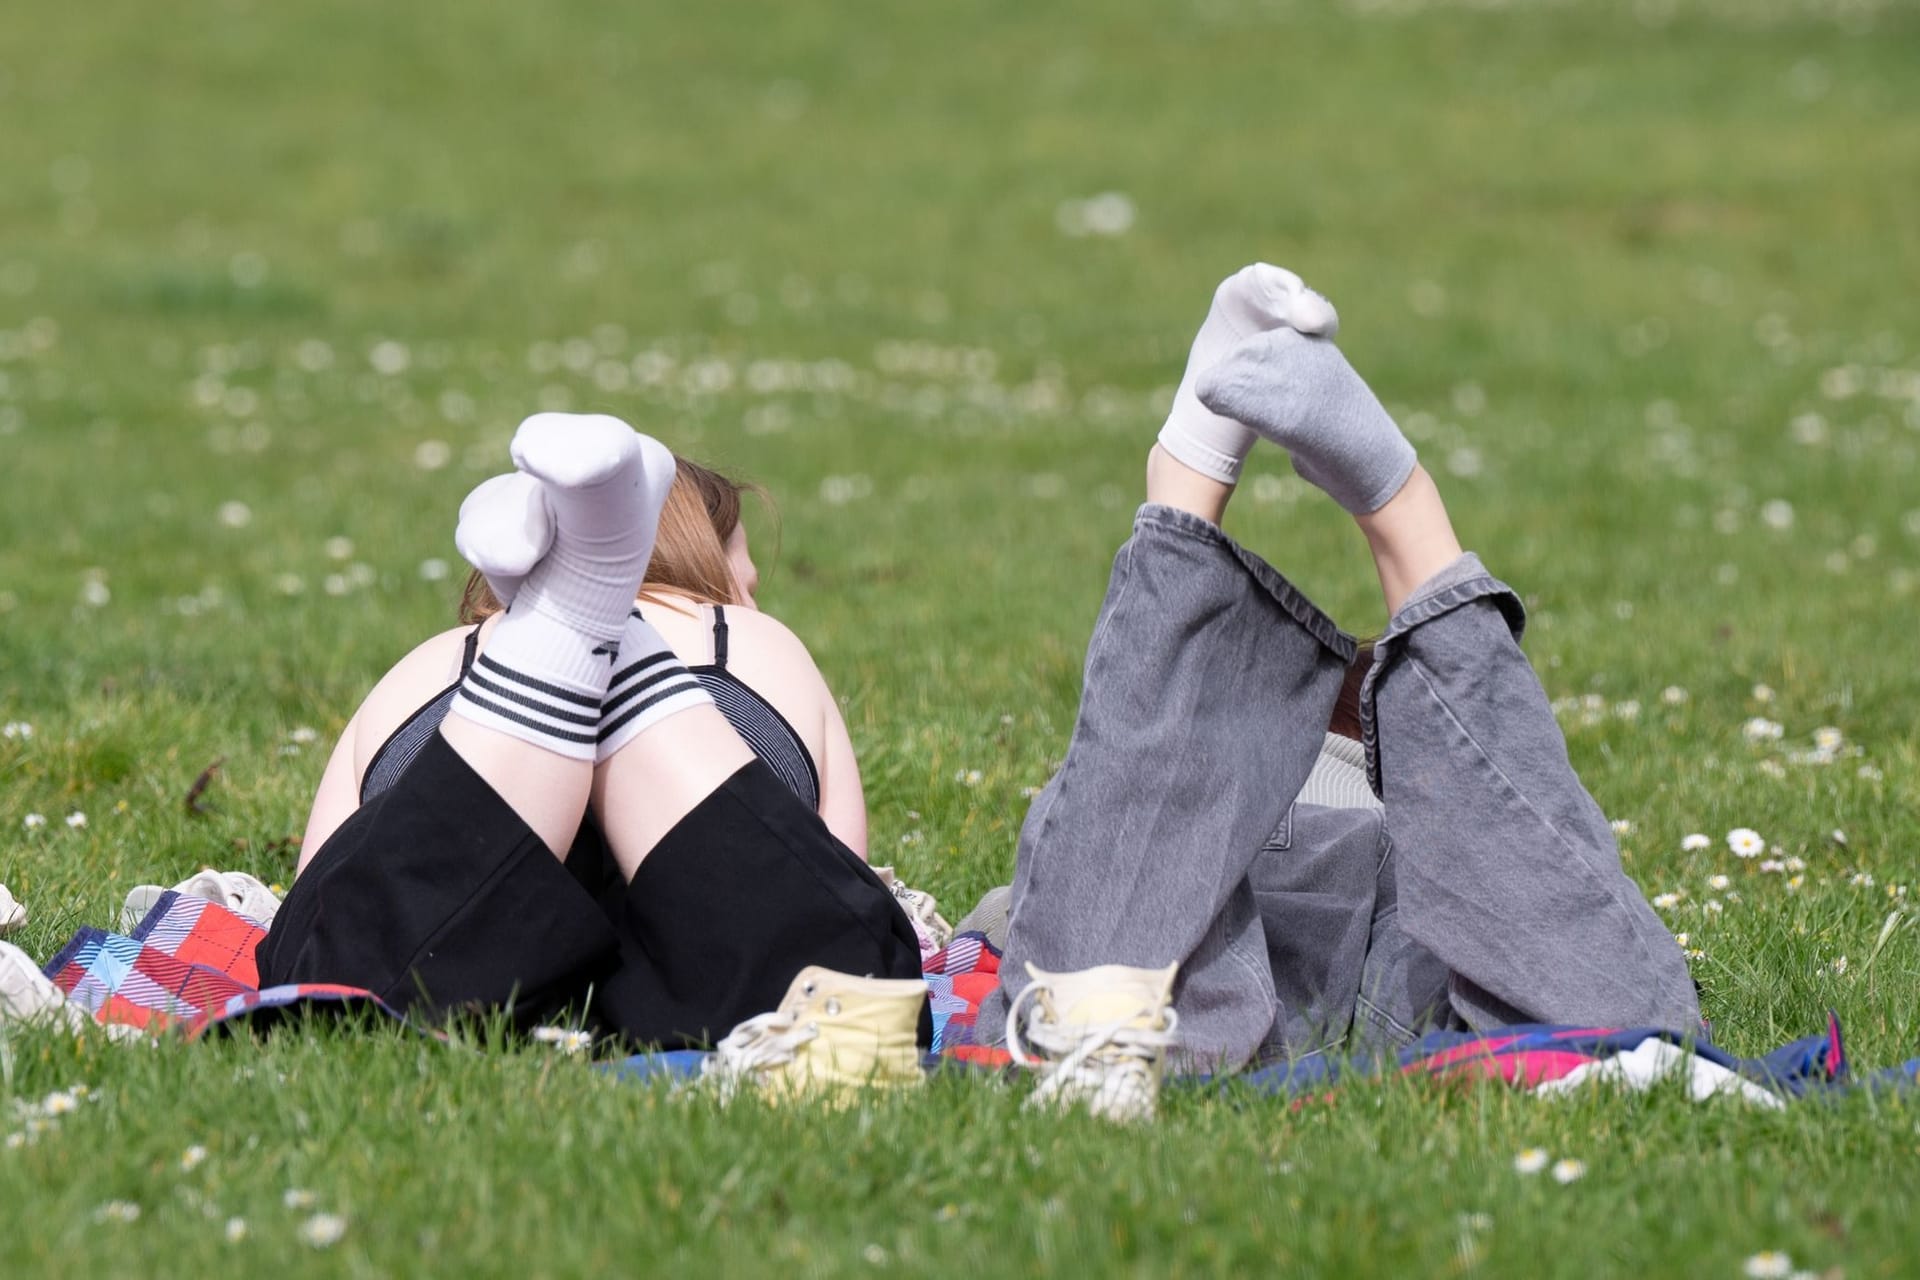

{"left": 1160, "top": 263, "right": 1340, "bottom": 486}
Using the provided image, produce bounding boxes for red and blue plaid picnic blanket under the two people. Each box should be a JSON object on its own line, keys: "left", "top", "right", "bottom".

{"left": 22, "top": 905, "right": 1920, "bottom": 1105}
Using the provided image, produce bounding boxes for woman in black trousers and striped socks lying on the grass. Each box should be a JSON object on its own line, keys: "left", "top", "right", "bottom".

{"left": 257, "top": 415, "right": 924, "bottom": 1050}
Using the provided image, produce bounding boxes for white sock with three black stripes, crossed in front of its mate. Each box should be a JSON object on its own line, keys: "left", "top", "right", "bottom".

{"left": 451, "top": 413, "right": 674, "bottom": 760}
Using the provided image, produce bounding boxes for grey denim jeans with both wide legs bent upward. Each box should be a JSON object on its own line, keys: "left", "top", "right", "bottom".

{"left": 975, "top": 505, "right": 1703, "bottom": 1069}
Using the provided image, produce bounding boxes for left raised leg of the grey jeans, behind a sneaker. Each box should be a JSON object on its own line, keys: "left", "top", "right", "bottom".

{"left": 975, "top": 505, "right": 1371, "bottom": 1067}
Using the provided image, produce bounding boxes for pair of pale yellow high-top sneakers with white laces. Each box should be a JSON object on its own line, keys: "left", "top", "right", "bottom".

{"left": 701, "top": 965, "right": 1179, "bottom": 1123}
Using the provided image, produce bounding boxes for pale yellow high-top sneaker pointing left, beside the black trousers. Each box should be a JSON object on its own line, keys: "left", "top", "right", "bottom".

{"left": 701, "top": 965, "right": 927, "bottom": 1102}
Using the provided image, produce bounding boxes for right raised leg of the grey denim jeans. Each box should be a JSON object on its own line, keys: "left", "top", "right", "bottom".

{"left": 1361, "top": 555, "right": 1701, "bottom": 1034}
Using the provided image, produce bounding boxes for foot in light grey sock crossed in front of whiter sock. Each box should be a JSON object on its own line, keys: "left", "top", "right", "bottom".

{"left": 1194, "top": 328, "right": 1415, "bottom": 516}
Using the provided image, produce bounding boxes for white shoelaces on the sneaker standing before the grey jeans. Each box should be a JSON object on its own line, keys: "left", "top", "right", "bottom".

{"left": 1006, "top": 983, "right": 1181, "bottom": 1121}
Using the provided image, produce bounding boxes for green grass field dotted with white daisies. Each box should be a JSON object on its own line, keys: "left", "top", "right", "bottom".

{"left": 0, "top": 0, "right": 1920, "bottom": 1280}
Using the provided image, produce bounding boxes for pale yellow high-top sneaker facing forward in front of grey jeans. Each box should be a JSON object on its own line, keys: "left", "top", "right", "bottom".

{"left": 1006, "top": 963, "right": 1179, "bottom": 1123}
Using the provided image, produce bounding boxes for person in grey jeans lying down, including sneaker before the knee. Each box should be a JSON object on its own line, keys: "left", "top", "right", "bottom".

{"left": 952, "top": 265, "right": 1705, "bottom": 1115}
